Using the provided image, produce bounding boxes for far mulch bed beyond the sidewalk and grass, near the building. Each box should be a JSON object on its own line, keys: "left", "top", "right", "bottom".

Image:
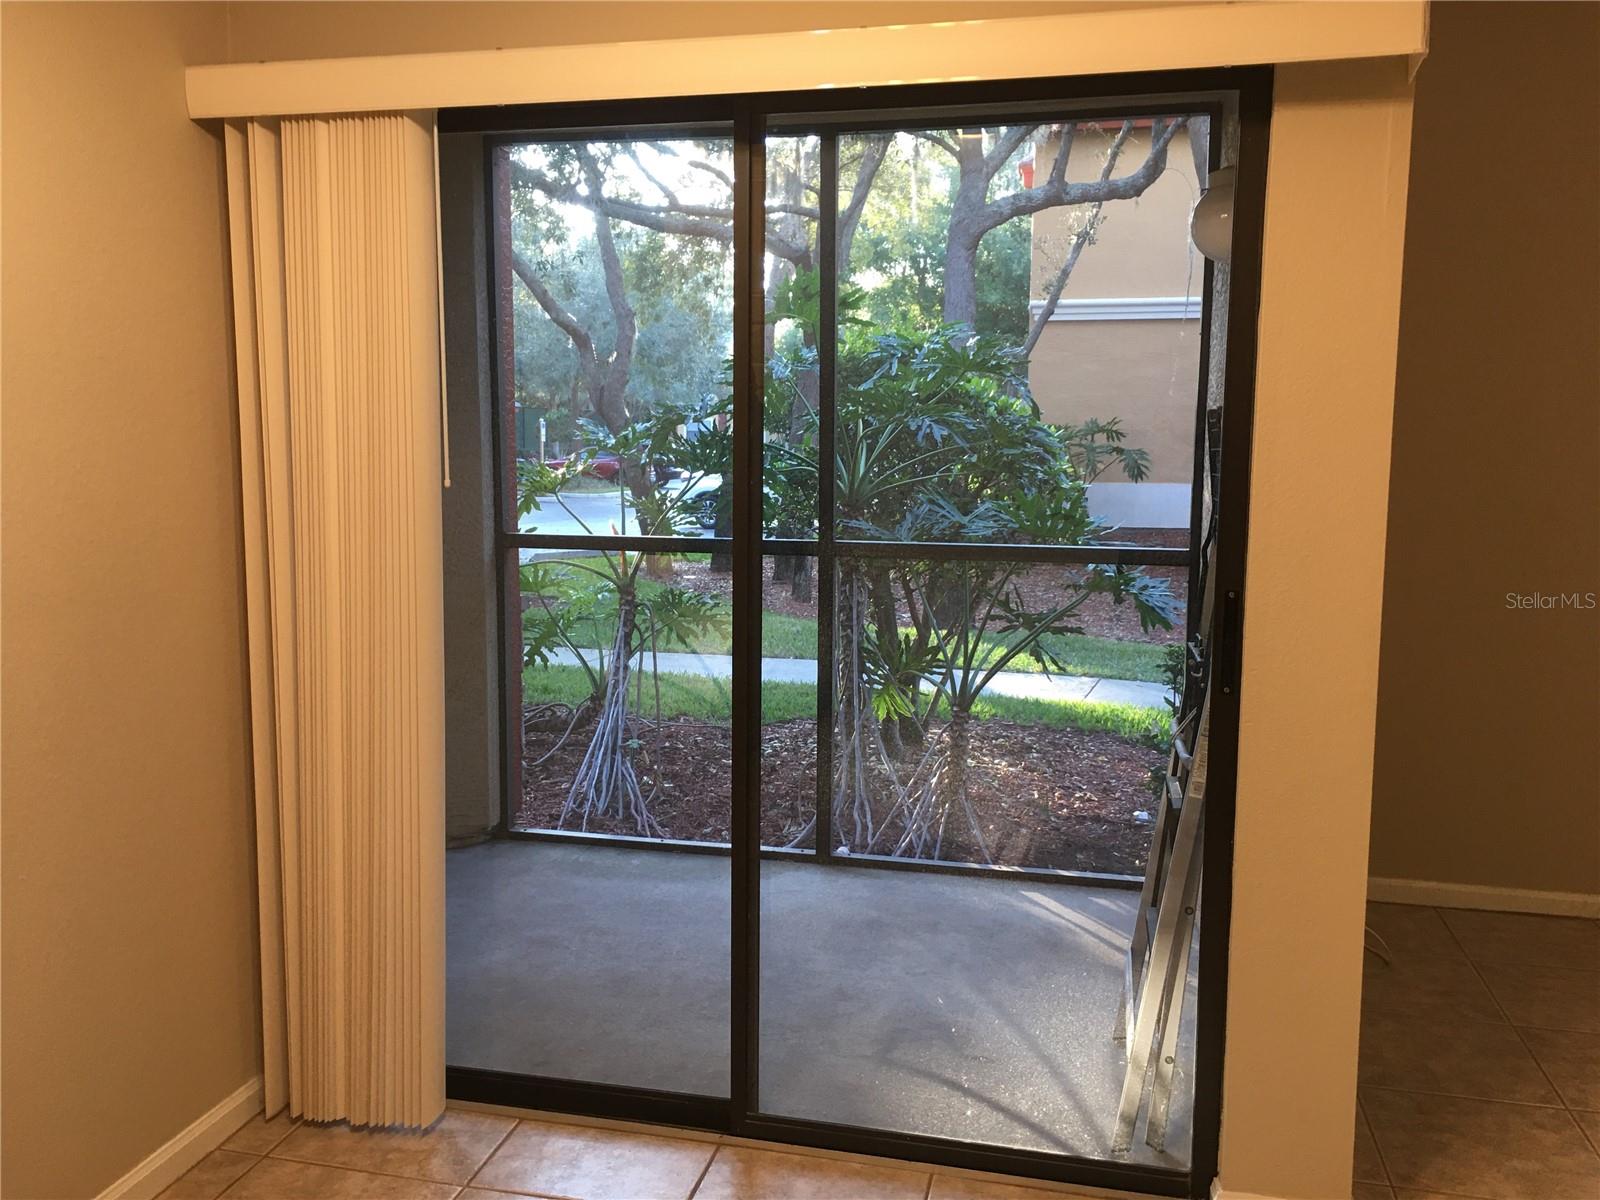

{"left": 672, "top": 530, "right": 1189, "bottom": 645}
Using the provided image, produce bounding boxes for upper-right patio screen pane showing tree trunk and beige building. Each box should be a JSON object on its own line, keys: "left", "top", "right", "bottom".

{"left": 835, "top": 117, "right": 1203, "bottom": 546}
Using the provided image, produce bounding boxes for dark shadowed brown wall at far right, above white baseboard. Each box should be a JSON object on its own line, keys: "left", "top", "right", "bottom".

{"left": 1371, "top": 3, "right": 1600, "bottom": 894}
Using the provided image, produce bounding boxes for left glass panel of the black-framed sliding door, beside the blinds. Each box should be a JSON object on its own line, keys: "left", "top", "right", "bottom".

{"left": 450, "top": 126, "right": 734, "bottom": 1096}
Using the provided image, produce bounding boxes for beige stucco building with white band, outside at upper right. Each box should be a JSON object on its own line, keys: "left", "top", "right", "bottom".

{"left": 1029, "top": 125, "right": 1205, "bottom": 528}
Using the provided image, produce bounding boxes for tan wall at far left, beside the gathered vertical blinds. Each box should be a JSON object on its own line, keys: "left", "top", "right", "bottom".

{"left": 0, "top": 5, "right": 258, "bottom": 1200}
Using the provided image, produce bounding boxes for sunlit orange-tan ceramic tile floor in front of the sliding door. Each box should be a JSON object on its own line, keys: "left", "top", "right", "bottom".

{"left": 162, "top": 1109, "right": 1113, "bottom": 1200}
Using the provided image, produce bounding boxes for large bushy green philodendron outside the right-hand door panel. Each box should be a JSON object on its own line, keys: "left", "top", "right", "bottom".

{"left": 768, "top": 326, "right": 1174, "bottom": 858}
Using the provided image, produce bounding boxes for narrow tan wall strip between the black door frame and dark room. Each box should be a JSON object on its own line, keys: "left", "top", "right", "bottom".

{"left": 1221, "top": 59, "right": 1411, "bottom": 1200}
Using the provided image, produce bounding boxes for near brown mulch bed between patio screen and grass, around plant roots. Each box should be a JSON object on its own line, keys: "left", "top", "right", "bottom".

{"left": 515, "top": 718, "right": 1163, "bottom": 875}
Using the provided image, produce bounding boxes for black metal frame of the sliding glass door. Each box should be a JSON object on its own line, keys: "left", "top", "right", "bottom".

{"left": 438, "top": 67, "right": 1272, "bottom": 1197}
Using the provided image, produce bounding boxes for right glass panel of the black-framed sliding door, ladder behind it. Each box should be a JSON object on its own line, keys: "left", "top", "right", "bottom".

{"left": 758, "top": 107, "right": 1210, "bottom": 1168}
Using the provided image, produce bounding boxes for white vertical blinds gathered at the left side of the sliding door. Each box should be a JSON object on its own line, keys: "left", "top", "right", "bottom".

{"left": 226, "top": 112, "right": 445, "bottom": 1126}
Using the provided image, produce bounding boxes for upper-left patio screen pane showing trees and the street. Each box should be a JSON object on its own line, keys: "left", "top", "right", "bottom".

{"left": 494, "top": 138, "right": 733, "bottom": 536}
